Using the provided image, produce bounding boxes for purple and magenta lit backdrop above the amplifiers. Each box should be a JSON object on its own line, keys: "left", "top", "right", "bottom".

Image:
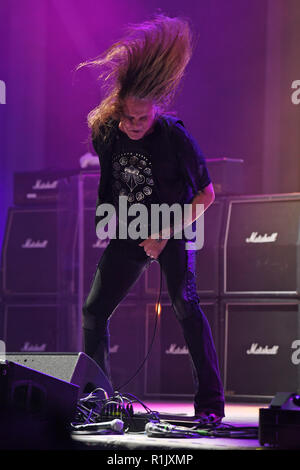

{"left": 0, "top": 0, "right": 300, "bottom": 248}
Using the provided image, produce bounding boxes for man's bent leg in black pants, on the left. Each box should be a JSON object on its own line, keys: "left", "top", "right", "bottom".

{"left": 83, "top": 239, "right": 149, "bottom": 379}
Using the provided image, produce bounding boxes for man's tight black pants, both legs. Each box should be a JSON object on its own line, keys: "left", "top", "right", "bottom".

{"left": 83, "top": 239, "right": 224, "bottom": 416}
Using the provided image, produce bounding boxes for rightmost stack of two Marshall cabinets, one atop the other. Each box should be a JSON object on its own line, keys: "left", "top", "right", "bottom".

{"left": 220, "top": 193, "right": 300, "bottom": 400}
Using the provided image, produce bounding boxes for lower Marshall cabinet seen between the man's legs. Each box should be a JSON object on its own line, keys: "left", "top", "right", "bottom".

{"left": 144, "top": 301, "right": 218, "bottom": 398}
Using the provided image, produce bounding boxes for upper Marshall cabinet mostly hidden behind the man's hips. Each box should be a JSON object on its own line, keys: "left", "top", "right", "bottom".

{"left": 143, "top": 197, "right": 225, "bottom": 298}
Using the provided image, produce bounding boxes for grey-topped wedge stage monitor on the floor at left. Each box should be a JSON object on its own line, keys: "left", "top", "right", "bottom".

{"left": 6, "top": 352, "right": 113, "bottom": 398}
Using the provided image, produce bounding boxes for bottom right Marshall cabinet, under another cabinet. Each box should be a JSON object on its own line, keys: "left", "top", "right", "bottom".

{"left": 221, "top": 299, "right": 300, "bottom": 401}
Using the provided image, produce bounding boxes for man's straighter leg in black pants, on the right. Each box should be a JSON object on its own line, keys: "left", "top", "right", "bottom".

{"left": 159, "top": 239, "right": 224, "bottom": 417}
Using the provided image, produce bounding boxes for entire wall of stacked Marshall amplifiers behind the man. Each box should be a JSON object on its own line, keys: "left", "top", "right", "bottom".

{"left": 0, "top": 163, "right": 300, "bottom": 401}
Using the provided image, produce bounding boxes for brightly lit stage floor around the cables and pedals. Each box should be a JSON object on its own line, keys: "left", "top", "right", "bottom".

{"left": 72, "top": 401, "right": 268, "bottom": 452}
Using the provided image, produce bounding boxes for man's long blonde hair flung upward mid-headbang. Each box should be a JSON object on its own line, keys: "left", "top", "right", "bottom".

{"left": 77, "top": 14, "right": 192, "bottom": 137}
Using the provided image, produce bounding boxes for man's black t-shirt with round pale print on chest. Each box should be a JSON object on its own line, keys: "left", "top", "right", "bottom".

{"left": 101, "top": 117, "right": 211, "bottom": 240}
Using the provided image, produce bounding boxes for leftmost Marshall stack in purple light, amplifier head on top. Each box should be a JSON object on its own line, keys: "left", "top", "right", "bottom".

{"left": 0, "top": 170, "right": 83, "bottom": 353}
